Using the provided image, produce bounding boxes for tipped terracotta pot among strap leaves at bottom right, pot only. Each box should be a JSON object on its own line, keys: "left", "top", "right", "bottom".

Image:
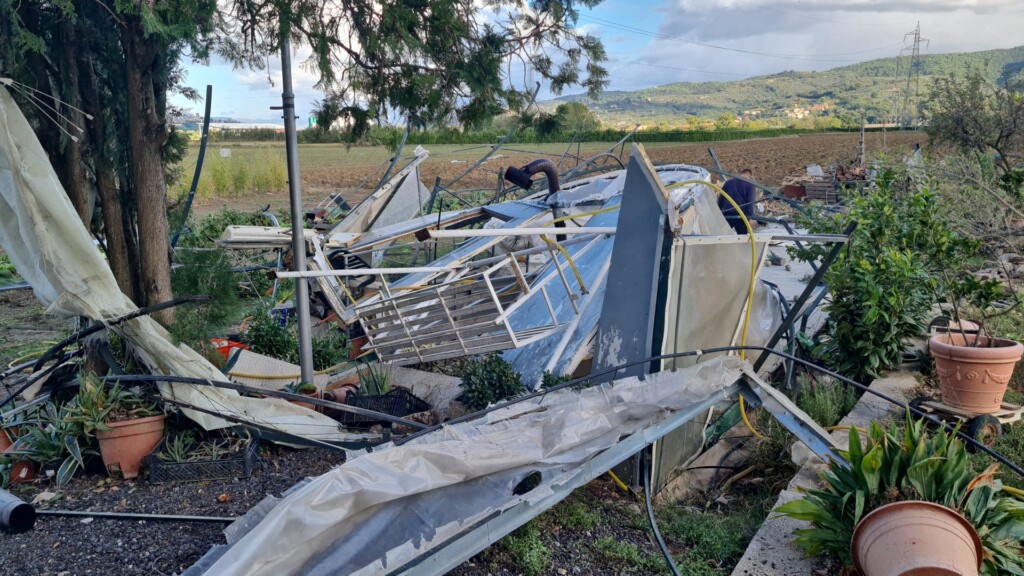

{"left": 850, "top": 500, "right": 983, "bottom": 576}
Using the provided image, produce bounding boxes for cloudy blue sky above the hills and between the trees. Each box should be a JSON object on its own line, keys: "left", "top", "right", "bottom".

{"left": 171, "top": 0, "right": 1024, "bottom": 127}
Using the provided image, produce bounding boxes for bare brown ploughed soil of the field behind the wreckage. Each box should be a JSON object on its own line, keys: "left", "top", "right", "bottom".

{"left": 188, "top": 132, "right": 928, "bottom": 215}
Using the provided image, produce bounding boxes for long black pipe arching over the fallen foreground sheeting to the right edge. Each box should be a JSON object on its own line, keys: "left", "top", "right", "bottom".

{"left": 394, "top": 346, "right": 1024, "bottom": 478}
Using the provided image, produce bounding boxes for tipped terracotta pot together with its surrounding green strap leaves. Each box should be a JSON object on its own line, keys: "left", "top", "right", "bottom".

{"left": 775, "top": 413, "right": 1024, "bottom": 576}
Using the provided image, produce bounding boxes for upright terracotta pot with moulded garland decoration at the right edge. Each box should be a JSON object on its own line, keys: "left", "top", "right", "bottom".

{"left": 928, "top": 333, "right": 1024, "bottom": 414}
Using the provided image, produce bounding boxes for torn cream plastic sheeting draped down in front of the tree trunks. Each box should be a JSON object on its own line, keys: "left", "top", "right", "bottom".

{"left": 0, "top": 87, "right": 352, "bottom": 441}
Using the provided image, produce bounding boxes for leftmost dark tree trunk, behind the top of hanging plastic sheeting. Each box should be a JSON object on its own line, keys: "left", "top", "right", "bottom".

{"left": 60, "top": 20, "right": 92, "bottom": 230}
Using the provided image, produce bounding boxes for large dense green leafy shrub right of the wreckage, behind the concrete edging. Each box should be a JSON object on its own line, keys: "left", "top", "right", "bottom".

{"left": 791, "top": 168, "right": 978, "bottom": 380}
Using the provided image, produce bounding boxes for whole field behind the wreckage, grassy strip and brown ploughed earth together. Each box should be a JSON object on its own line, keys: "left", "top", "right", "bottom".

{"left": 186, "top": 132, "right": 927, "bottom": 213}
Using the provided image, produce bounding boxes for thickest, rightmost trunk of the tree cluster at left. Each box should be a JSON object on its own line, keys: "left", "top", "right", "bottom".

{"left": 123, "top": 16, "right": 173, "bottom": 323}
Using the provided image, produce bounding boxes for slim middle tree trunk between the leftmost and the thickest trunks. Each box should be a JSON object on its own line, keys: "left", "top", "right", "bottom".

{"left": 78, "top": 49, "right": 142, "bottom": 304}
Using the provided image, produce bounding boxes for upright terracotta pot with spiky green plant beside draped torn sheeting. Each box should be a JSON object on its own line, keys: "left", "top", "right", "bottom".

{"left": 70, "top": 376, "right": 167, "bottom": 479}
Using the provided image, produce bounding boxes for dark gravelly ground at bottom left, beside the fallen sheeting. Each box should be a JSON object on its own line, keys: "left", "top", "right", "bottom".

{"left": 0, "top": 449, "right": 344, "bottom": 576}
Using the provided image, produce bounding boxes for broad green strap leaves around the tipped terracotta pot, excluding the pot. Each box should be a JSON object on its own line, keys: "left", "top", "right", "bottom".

{"left": 775, "top": 412, "right": 1024, "bottom": 576}
